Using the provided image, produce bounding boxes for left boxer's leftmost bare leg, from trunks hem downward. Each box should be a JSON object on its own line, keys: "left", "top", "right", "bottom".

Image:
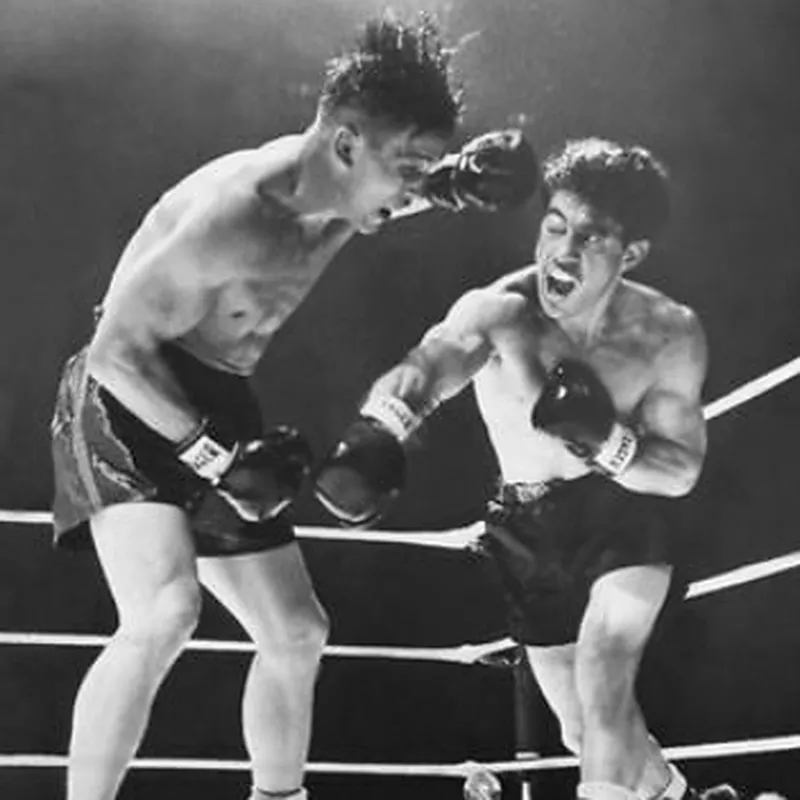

{"left": 67, "top": 503, "right": 200, "bottom": 800}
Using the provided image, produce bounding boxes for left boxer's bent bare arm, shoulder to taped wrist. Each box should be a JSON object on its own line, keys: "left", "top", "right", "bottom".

{"left": 88, "top": 191, "right": 238, "bottom": 442}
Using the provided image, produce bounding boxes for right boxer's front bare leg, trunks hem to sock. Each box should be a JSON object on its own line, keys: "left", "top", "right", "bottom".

{"left": 575, "top": 566, "right": 671, "bottom": 797}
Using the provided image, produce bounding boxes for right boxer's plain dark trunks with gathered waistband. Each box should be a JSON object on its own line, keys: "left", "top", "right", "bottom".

{"left": 472, "top": 474, "right": 682, "bottom": 646}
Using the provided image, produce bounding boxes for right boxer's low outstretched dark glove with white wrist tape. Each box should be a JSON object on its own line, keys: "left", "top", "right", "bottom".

{"left": 315, "top": 396, "right": 420, "bottom": 527}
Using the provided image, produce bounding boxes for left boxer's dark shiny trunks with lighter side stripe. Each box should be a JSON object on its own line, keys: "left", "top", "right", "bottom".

{"left": 51, "top": 344, "right": 294, "bottom": 556}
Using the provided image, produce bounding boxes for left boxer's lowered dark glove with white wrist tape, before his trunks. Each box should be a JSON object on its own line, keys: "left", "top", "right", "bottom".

{"left": 176, "top": 420, "right": 312, "bottom": 522}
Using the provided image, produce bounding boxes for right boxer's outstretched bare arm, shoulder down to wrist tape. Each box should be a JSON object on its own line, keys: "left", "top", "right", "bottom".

{"left": 360, "top": 289, "right": 515, "bottom": 432}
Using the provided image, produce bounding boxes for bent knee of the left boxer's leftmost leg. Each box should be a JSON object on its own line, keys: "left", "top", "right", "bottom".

{"left": 117, "top": 580, "right": 202, "bottom": 654}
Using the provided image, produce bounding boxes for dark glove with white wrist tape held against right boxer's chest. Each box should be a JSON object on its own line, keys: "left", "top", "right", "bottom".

{"left": 531, "top": 359, "right": 638, "bottom": 476}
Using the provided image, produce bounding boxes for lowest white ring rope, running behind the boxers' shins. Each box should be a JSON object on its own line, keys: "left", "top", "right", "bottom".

{"left": 0, "top": 735, "right": 800, "bottom": 778}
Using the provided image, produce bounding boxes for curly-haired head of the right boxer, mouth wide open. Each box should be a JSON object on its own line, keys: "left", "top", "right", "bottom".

{"left": 536, "top": 138, "right": 669, "bottom": 318}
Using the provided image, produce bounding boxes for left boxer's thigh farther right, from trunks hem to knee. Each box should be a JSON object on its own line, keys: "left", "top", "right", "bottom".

{"left": 198, "top": 542, "right": 326, "bottom": 643}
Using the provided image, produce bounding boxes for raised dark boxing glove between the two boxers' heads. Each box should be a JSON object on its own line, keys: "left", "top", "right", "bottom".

{"left": 421, "top": 128, "right": 539, "bottom": 211}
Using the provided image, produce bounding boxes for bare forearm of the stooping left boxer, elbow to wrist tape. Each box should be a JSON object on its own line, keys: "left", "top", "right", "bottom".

{"left": 88, "top": 347, "right": 200, "bottom": 442}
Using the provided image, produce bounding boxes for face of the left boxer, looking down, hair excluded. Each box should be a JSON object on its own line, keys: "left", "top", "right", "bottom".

{"left": 332, "top": 123, "right": 446, "bottom": 233}
